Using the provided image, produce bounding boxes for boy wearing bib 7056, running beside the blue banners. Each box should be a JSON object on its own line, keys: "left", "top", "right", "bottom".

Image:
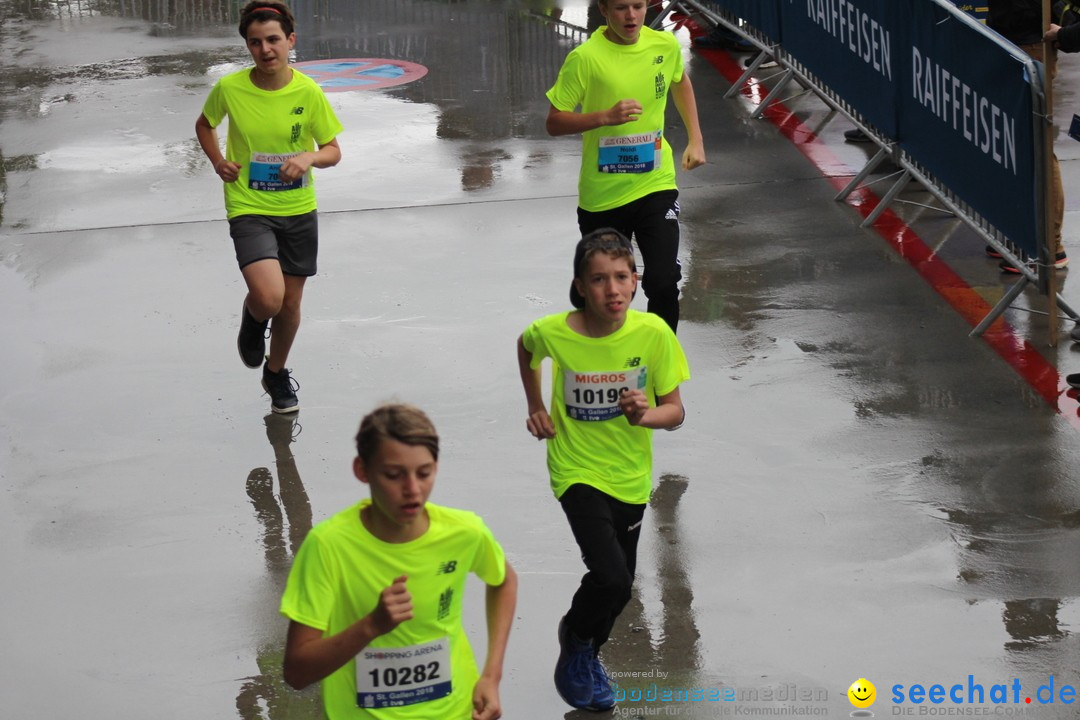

{"left": 546, "top": 0, "right": 705, "bottom": 330}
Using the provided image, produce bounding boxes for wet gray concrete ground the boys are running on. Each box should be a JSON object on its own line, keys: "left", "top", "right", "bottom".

{"left": 6, "top": 0, "right": 1080, "bottom": 720}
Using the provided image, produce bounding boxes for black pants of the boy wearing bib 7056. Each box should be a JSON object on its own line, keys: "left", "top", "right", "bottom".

{"left": 578, "top": 190, "right": 683, "bottom": 332}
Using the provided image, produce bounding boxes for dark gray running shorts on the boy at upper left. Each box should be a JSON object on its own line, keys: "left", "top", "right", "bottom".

{"left": 229, "top": 210, "right": 319, "bottom": 277}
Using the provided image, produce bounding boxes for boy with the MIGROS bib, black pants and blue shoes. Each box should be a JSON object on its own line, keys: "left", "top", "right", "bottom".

{"left": 517, "top": 228, "right": 690, "bottom": 710}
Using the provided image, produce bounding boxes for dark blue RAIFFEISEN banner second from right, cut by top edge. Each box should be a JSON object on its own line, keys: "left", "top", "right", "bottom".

{"left": 781, "top": 0, "right": 907, "bottom": 138}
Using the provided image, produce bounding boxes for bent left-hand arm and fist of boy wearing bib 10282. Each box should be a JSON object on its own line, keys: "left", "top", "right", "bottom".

{"left": 283, "top": 575, "right": 413, "bottom": 690}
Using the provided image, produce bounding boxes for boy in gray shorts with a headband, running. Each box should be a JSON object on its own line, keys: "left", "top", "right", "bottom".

{"left": 195, "top": 0, "right": 341, "bottom": 413}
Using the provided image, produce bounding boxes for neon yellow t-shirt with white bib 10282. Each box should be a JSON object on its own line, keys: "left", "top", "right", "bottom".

{"left": 281, "top": 499, "right": 507, "bottom": 720}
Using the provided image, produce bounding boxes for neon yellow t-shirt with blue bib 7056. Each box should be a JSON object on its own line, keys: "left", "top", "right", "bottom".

{"left": 548, "top": 26, "right": 683, "bottom": 213}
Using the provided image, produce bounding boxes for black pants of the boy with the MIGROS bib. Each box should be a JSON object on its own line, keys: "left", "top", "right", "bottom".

{"left": 559, "top": 484, "right": 645, "bottom": 648}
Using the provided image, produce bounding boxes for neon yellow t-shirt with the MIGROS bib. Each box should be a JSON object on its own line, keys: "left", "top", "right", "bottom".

{"left": 522, "top": 310, "right": 690, "bottom": 504}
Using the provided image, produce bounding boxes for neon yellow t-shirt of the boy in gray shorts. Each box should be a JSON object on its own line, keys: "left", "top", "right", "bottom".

{"left": 203, "top": 68, "right": 342, "bottom": 218}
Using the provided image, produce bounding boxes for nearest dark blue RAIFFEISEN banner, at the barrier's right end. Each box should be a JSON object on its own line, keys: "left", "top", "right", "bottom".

{"left": 897, "top": 0, "right": 1041, "bottom": 256}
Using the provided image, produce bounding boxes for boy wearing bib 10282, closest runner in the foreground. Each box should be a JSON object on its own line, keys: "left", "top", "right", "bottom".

{"left": 281, "top": 405, "right": 517, "bottom": 720}
